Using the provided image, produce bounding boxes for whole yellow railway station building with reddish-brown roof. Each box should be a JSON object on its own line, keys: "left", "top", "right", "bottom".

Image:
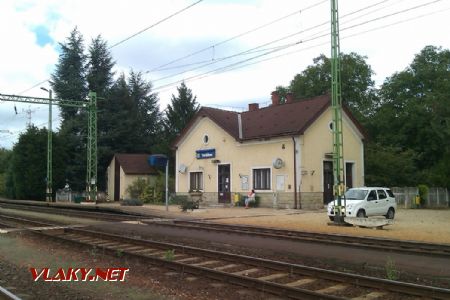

{"left": 172, "top": 92, "right": 365, "bottom": 208}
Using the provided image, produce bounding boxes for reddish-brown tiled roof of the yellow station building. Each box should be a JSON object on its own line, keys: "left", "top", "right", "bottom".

{"left": 173, "top": 95, "right": 365, "bottom": 146}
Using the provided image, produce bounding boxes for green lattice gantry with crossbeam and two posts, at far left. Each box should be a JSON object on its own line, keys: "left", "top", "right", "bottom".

{"left": 0, "top": 92, "right": 97, "bottom": 201}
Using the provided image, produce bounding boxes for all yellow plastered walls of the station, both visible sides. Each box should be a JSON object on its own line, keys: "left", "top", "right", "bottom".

{"left": 175, "top": 109, "right": 364, "bottom": 207}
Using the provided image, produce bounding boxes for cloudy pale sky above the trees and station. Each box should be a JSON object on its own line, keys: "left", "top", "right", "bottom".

{"left": 0, "top": 0, "right": 450, "bottom": 148}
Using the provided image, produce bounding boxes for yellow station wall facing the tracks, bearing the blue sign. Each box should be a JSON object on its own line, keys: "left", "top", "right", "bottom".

{"left": 176, "top": 118, "right": 294, "bottom": 193}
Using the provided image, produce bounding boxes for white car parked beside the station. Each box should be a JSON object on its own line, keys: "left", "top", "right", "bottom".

{"left": 327, "top": 187, "right": 397, "bottom": 221}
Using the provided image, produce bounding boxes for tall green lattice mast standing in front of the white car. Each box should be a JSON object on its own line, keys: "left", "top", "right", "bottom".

{"left": 331, "top": 0, "right": 345, "bottom": 225}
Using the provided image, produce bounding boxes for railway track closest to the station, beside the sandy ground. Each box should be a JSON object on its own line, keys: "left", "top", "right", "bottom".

{"left": 143, "top": 220, "right": 450, "bottom": 258}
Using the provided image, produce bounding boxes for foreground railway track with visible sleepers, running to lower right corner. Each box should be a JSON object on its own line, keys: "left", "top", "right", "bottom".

{"left": 1, "top": 214, "right": 450, "bottom": 300}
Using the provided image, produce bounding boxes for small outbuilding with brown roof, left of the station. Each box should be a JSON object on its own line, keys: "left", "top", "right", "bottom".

{"left": 107, "top": 154, "right": 158, "bottom": 201}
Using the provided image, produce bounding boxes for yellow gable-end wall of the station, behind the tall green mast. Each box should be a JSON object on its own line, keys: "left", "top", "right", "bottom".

{"left": 300, "top": 109, "right": 364, "bottom": 192}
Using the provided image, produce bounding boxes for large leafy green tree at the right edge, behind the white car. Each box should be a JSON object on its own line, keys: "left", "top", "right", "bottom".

{"left": 369, "top": 46, "right": 450, "bottom": 187}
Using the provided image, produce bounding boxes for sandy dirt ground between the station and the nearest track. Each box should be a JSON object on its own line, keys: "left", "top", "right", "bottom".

{"left": 111, "top": 205, "right": 450, "bottom": 244}
